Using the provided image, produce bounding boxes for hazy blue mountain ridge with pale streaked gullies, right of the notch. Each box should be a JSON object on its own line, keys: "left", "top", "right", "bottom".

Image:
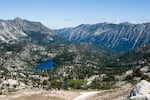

{"left": 55, "top": 23, "right": 150, "bottom": 51}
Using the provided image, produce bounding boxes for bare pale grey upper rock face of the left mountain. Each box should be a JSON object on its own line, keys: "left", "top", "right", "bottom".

{"left": 0, "top": 18, "right": 54, "bottom": 43}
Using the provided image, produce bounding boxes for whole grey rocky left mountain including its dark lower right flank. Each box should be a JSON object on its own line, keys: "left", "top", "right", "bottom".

{"left": 0, "top": 18, "right": 63, "bottom": 44}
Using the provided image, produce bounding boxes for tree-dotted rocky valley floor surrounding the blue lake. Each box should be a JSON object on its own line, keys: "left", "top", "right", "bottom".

{"left": 0, "top": 37, "right": 150, "bottom": 89}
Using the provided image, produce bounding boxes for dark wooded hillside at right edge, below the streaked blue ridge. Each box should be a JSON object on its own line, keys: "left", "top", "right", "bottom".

{"left": 118, "top": 45, "right": 150, "bottom": 67}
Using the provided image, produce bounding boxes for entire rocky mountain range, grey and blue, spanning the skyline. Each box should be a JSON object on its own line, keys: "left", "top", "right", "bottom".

{"left": 0, "top": 18, "right": 150, "bottom": 51}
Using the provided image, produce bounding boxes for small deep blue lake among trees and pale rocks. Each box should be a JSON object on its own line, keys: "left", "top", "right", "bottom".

{"left": 34, "top": 60, "right": 53, "bottom": 71}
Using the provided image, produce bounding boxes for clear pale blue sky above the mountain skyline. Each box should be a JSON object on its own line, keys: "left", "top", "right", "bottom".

{"left": 0, "top": 0, "right": 150, "bottom": 29}
